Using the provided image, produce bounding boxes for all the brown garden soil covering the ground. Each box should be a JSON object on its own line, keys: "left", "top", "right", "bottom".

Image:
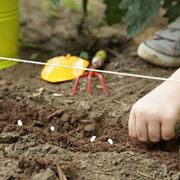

{"left": 0, "top": 0, "right": 180, "bottom": 180}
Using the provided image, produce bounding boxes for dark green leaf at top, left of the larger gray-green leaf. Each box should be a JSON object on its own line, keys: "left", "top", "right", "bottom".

{"left": 104, "top": 0, "right": 126, "bottom": 25}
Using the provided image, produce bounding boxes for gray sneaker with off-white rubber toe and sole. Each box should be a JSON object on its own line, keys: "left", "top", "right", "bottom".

{"left": 137, "top": 18, "right": 180, "bottom": 67}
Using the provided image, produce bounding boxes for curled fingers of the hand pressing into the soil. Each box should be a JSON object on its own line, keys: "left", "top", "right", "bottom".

{"left": 128, "top": 103, "right": 176, "bottom": 143}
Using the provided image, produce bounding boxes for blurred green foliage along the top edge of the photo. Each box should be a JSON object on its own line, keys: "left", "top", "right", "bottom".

{"left": 47, "top": 0, "right": 180, "bottom": 38}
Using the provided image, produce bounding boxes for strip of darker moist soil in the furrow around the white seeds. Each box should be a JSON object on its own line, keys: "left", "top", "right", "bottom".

{"left": 0, "top": 98, "right": 180, "bottom": 159}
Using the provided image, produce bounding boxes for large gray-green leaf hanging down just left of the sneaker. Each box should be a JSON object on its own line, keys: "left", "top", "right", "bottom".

{"left": 120, "top": 0, "right": 160, "bottom": 38}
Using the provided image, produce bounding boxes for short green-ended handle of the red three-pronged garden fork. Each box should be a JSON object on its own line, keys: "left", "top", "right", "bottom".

{"left": 92, "top": 50, "right": 107, "bottom": 68}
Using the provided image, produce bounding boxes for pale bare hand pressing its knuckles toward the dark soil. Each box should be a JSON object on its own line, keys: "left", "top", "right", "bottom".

{"left": 129, "top": 78, "right": 180, "bottom": 143}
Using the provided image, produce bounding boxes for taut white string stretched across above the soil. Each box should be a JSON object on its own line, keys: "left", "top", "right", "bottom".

{"left": 0, "top": 57, "right": 180, "bottom": 83}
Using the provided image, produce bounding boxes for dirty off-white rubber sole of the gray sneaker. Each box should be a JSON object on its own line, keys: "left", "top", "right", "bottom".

{"left": 137, "top": 43, "right": 180, "bottom": 67}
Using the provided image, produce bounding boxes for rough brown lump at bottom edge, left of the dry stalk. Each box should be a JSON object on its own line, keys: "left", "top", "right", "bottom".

{"left": 31, "top": 168, "right": 58, "bottom": 180}
